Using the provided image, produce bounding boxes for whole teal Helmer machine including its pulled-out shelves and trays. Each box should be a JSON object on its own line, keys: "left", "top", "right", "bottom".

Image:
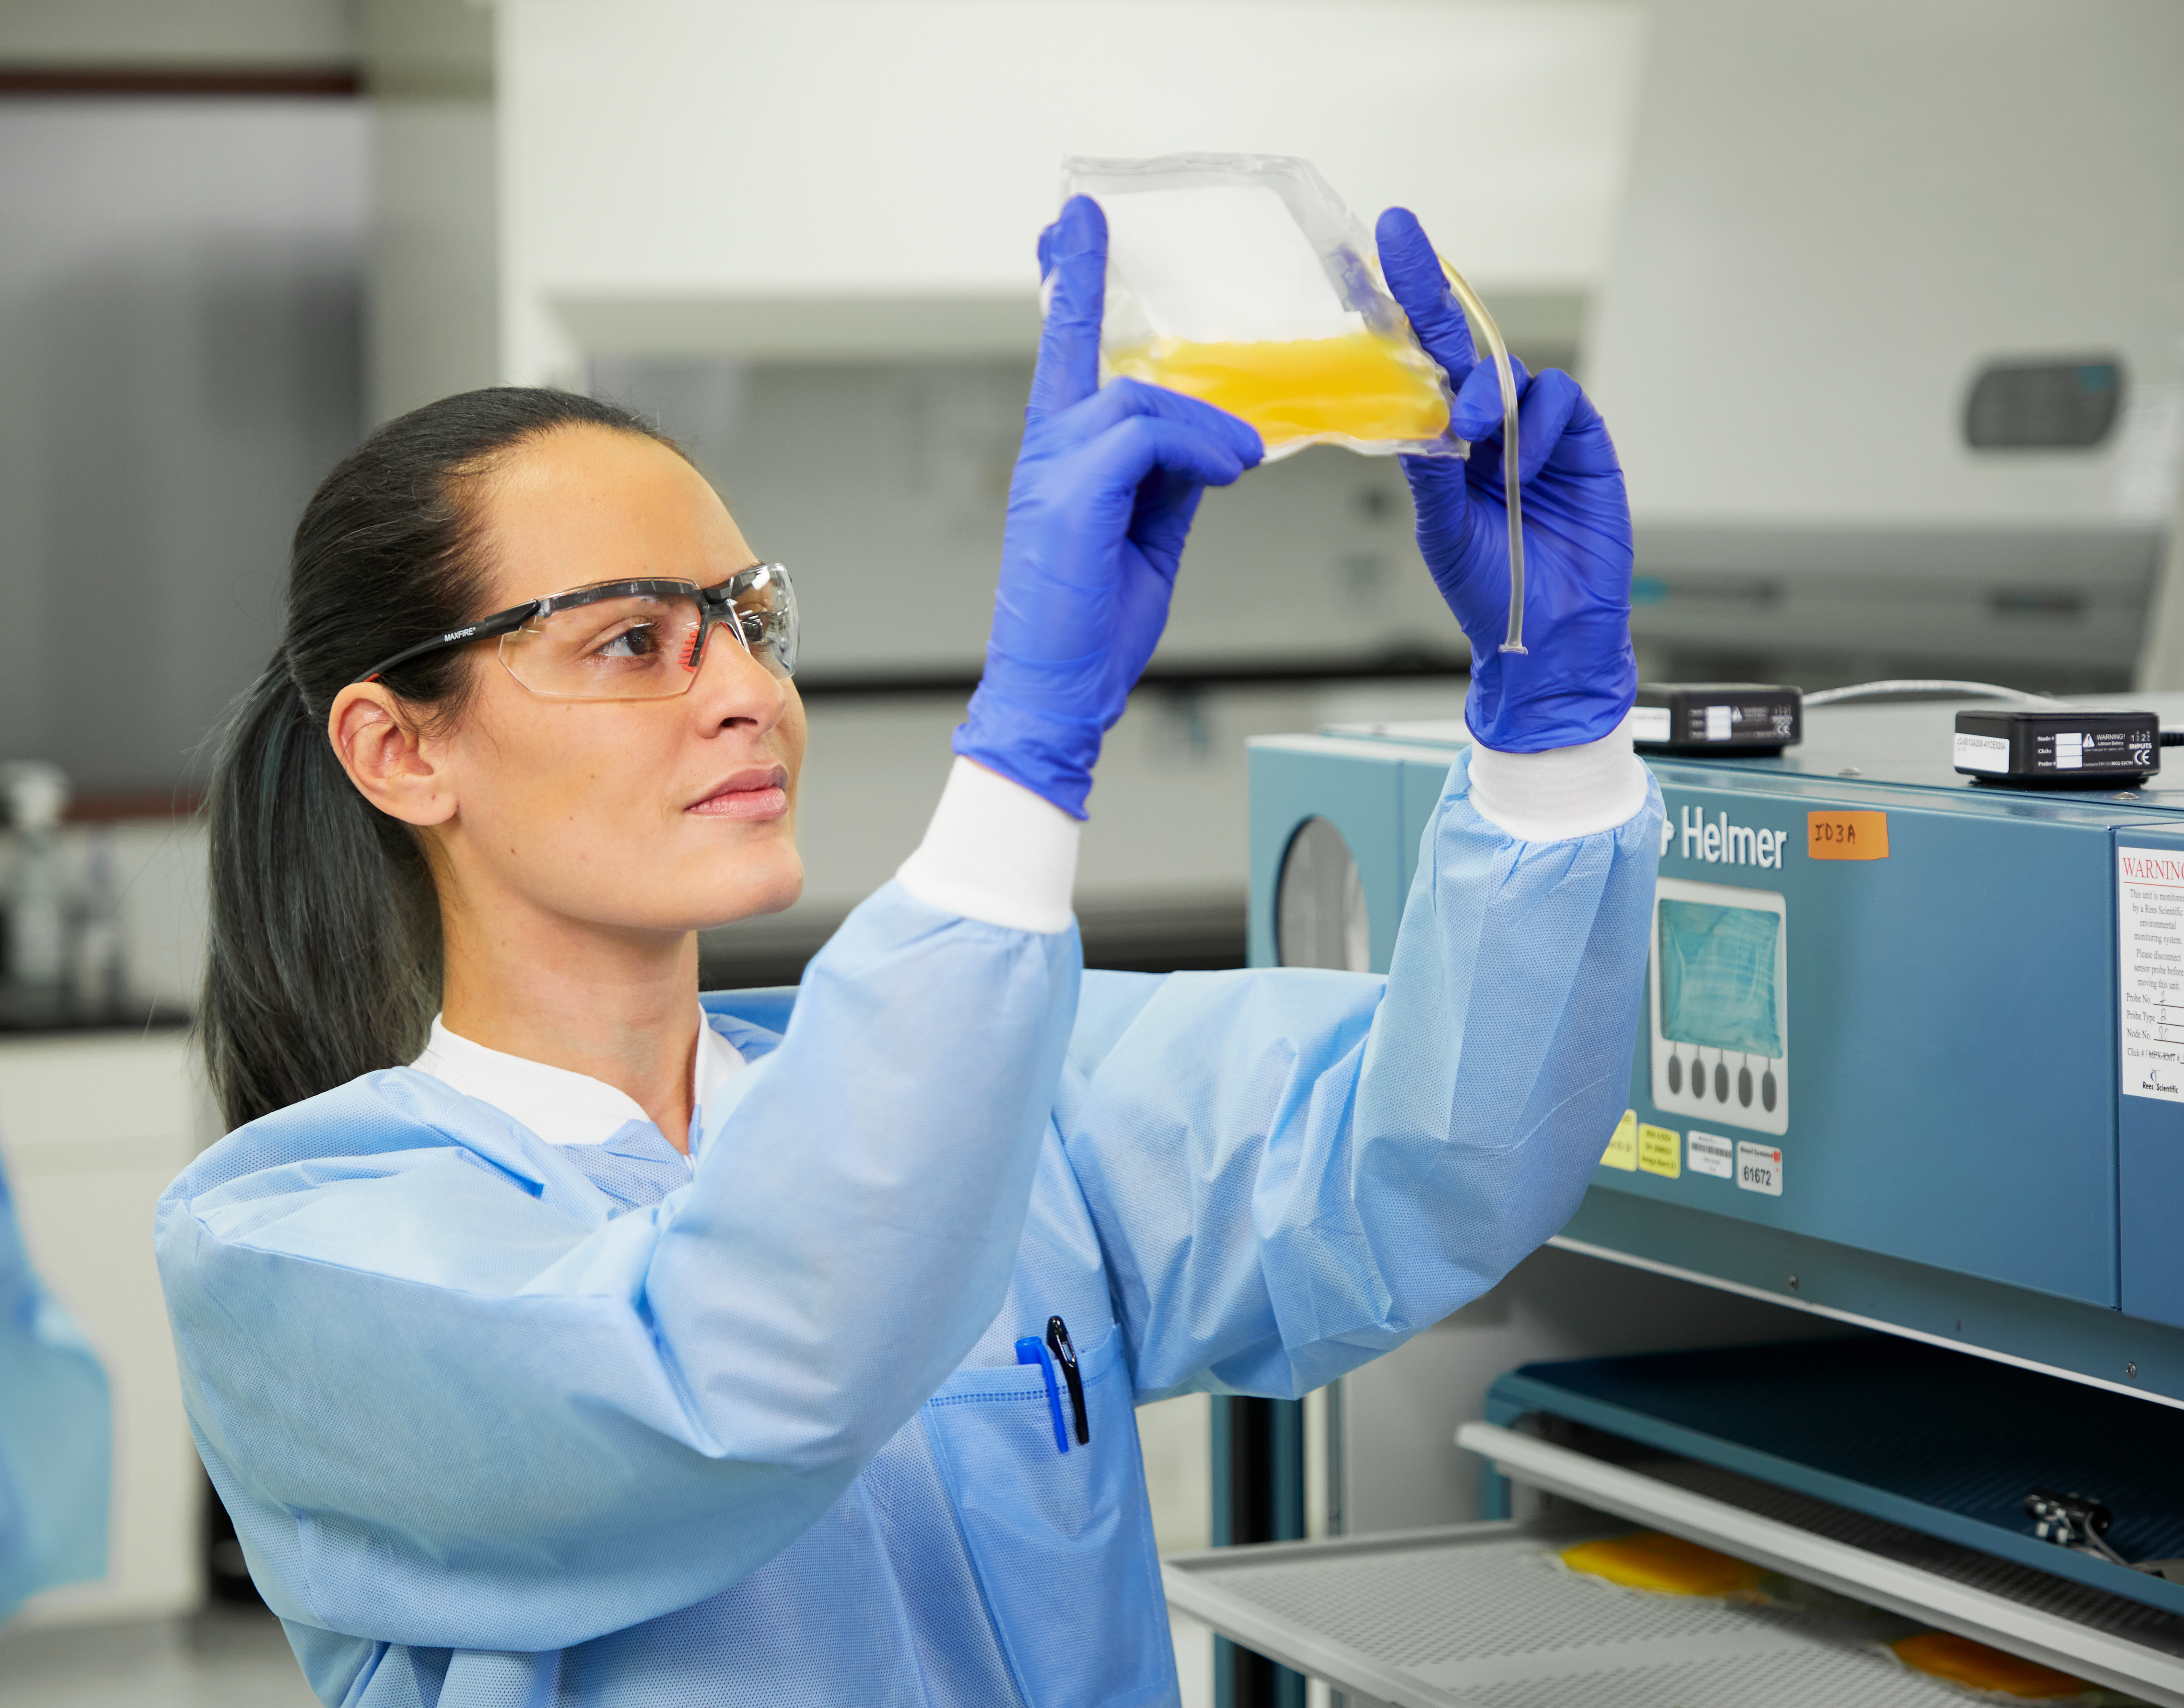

{"left": 1205, "top": 695, "right": 2184, "bottom": 1708}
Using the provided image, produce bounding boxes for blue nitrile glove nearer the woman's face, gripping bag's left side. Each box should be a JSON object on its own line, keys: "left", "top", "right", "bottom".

{"left": 954, "top": 197, "right": 1262, "bottom": 819}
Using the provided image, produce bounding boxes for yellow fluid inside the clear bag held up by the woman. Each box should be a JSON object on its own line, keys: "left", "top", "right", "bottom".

{"left": 1107, "top": 332, "right": 1448, "bottom": 452}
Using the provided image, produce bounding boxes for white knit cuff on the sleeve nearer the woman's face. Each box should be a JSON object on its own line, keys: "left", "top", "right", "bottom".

{"left": 895, "top": 760, "right": 1083, "bottom": 933}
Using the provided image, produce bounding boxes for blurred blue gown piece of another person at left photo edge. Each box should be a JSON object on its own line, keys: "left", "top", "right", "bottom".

{"left": 0, "top": 1171, "right": 113, "bottom": 1621}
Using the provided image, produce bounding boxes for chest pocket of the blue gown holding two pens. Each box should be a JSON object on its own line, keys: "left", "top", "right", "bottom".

{"left": 924, "top": 1326, "right": 1177, "bottom": 1708}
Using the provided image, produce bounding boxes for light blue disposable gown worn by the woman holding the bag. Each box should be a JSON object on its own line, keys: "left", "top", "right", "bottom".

{"left": 159, "top": 760, "right": 1660, "bottom": 1708}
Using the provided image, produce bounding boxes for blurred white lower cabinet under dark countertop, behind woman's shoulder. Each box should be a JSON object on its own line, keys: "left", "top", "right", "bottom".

{"left": 0, "top": 1026, "right": 214, "bottom": 1625}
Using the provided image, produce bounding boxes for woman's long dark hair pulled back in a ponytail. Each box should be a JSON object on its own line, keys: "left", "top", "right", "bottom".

{"left": 199, "top": 386, "right": 675, "bottom": 1127}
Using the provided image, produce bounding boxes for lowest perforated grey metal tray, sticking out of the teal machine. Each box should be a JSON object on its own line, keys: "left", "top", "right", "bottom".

{"left": 1162, "top": 1522, "right": 2096, "bottom": 1708}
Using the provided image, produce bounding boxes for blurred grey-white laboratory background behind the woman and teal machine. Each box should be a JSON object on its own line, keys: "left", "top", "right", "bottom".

{"left": 0, "top": 0, "right": 2184, "bottom": 1708}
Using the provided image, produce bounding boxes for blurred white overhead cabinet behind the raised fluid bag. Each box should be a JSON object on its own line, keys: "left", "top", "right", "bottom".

{"left": 498, "top": 0, "right": 1642, "bottom": 380}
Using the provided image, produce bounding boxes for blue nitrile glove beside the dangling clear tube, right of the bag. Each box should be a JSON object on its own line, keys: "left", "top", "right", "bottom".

{"left": 1378, "top": 208, "right": 1638, "bottom": 753}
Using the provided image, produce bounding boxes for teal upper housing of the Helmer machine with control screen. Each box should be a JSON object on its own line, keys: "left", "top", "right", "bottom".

{"left": 1251, "top": 695, "right": 2184, "bottom": 1400}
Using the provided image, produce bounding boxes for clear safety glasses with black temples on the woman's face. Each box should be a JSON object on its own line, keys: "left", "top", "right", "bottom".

{"left": 358, "top": 564, "right": 797, "bottom": 699}
